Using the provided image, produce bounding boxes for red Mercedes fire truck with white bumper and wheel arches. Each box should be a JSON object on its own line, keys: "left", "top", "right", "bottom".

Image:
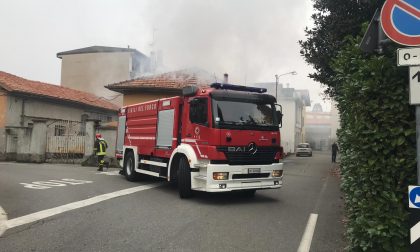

{"left": 116, "top": 83, "right": 283, "bottom": 198}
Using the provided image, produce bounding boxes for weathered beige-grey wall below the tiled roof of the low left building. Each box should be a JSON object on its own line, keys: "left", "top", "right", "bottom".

{"left": 0, "top": 95, "right": 117, "bottom": 162}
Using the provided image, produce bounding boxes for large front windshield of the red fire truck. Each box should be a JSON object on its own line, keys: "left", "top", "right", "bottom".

{"left": 212, "top": 99, "right": 278, "bottom": 130}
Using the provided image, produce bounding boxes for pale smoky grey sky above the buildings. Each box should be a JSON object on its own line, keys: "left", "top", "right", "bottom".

{"left": 0, "top": 0, "right": 329, "bottom": 110}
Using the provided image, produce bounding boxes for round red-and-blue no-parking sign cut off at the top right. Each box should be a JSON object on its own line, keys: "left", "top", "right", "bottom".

{"left": 381, "top": 0, "right": 420, "bottom": 46}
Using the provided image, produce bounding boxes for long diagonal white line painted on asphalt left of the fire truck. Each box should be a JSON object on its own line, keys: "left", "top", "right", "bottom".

{"left": 6, "top": 183, "right": 162, "bottom": 228}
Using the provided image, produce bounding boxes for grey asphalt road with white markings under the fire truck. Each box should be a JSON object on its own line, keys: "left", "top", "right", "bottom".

{"left": 0, "top": 153, "right": 345, "bottom": 252}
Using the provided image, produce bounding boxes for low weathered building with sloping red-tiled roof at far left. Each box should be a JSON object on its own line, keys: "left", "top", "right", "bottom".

{"left": 0, "top": 71, "right": 118, "bottom": 162}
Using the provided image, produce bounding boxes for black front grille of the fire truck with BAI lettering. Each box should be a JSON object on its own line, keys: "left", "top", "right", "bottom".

{"left": 217, "top": 146, "right": 279, "bottom": 165}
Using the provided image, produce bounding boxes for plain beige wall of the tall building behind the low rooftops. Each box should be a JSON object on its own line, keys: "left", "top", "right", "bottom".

{"left": 61, "top": 52, "right": 132, "bottom": 106}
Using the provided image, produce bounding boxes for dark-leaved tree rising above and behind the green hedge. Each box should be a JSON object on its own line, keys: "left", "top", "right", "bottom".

{"left": 299, "top": 0, "right": 384, "bottom": 97}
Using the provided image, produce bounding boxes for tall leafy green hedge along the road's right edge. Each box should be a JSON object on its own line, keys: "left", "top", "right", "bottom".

{"left": 332, "top": 38, "right": 416, "bottom": 251}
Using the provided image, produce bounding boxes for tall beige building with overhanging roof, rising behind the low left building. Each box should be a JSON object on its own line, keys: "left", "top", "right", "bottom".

{"left": 57, "top": 46, "right": 150, "bottom": 106}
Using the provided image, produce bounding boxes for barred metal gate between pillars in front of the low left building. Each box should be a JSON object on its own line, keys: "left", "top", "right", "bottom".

{"left": 46, "top": 121, "right": 86, "bottom": 163}
